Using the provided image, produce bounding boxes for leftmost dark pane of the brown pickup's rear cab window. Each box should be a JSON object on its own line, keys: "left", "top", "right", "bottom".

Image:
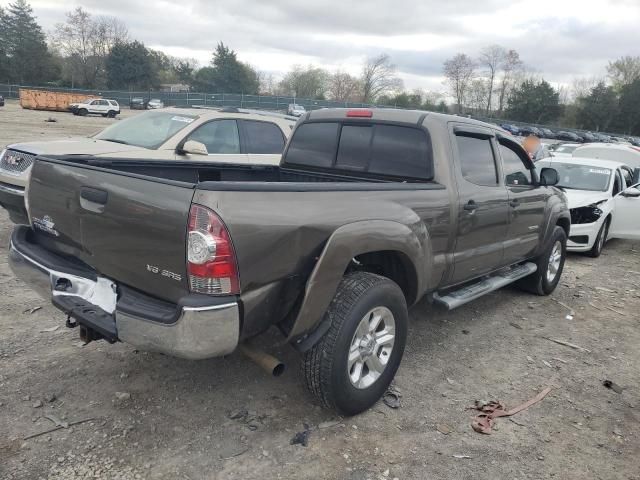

{"left": 285, "top": 122, "right": 340, "bottom": 168}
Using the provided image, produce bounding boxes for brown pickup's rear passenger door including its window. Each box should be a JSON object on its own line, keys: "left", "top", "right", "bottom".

{"left": 449, "top": 125, "right": 509, "bottom": 284}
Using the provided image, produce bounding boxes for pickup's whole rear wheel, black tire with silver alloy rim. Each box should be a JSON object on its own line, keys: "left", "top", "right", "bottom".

{"left": 302, "top": 272, "right": 408, "bottom": 415}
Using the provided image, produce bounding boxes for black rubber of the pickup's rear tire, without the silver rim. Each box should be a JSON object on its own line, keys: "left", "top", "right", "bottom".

{"left": 302, "top": 272, "right": 409, "bottom": 415}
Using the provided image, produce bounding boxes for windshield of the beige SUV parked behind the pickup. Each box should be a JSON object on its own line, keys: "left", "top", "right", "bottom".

{"left": 94, "top": 112, "right": 198, "bottom": 150}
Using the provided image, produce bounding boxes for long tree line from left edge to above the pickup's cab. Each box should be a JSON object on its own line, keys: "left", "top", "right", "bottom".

{"left": 0, "top": 0, "right": 447, "bottom": 111}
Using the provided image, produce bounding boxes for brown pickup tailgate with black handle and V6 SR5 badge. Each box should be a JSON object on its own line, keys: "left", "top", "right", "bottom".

{"left": 27, "top": 158, "right": 193, "bottom": 302}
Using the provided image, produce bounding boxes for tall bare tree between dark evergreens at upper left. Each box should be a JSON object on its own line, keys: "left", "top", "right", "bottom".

{"left": 52, "top": 7, "right": 129, "bottom": 87}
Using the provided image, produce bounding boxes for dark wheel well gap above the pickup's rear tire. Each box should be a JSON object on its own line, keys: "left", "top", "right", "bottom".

{"left": 345, "top": 250, "right": 418, "bottom": 305}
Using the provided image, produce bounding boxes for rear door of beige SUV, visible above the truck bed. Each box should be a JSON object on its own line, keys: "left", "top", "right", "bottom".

{"left": 238, "top": 120, "right": 286, "bottom": 165}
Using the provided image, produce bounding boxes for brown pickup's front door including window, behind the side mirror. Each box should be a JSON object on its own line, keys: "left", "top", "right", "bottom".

{"left": 498, "top": 139, "right": 551, "bottom": 263}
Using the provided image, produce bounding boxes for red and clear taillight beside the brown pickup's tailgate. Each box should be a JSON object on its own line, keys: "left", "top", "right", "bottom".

{"left": 187, "top": 205, "right": 240, "bottom": 295}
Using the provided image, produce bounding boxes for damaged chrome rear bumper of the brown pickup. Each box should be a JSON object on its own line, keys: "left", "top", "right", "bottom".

{"left": 9, "top": 238, "right": 240, "bottom": 360}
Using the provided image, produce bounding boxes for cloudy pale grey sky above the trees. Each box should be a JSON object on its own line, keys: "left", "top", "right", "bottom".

{"left": 5, "top": 0, "right": 640, "bottom": 91}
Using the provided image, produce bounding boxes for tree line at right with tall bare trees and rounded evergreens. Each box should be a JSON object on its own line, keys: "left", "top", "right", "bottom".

{"left": 443, "top": 45, "right": 640, "bottom": 135}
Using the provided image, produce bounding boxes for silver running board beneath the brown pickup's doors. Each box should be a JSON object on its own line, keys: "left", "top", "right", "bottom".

{"left": 433, "top": 262, "right": 538, "bottom": 310}
